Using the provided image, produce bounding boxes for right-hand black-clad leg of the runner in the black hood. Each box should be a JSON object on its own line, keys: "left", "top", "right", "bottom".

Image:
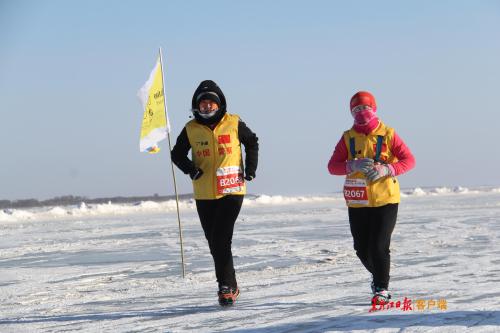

{"left": 211, "top": 195, "right": 243, "bottom": 288}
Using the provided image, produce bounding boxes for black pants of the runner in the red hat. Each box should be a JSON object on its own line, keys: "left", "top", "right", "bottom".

{"left": 349, "top": 204, "right": 398, "bottom": 289}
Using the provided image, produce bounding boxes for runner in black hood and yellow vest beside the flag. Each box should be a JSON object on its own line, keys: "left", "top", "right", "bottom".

{"left": 172, "top": 80, "right": 259, "bottom": 305}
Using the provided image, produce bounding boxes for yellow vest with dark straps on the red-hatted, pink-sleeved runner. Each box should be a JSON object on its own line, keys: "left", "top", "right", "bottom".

{"left": 344, "top": 122, "right": 400, "bottom": 208}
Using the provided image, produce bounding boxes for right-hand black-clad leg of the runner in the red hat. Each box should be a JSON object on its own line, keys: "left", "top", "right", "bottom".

{"left": 369, "top": 204, "right": 398, "bottom": 289}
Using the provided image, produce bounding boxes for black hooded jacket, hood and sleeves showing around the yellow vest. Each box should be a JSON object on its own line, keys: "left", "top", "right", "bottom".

{"left": 171, "top": 80, "right": 259, "bottom": 177}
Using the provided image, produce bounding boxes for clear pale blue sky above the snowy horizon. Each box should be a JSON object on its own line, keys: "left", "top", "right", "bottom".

{"left": 0, "top": 0, "right": 500, "bottom": 199}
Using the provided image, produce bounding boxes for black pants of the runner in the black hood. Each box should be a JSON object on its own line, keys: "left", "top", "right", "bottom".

{"left": 196, "top": 195, "right": 243, "bottom": 288}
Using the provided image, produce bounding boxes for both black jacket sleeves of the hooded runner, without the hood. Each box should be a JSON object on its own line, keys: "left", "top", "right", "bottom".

{"left": 171, "top": 120, "right": 259, "bottom": 177}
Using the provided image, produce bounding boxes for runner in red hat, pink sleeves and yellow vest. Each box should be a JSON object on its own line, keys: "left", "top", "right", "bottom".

{"left": 328, "top": 91, "right": 415, "bottom": 304}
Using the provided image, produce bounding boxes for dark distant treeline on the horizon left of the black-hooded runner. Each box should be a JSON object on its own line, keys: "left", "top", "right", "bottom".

{"left": 0, "top": 194, "right": 193, "bottom": 209}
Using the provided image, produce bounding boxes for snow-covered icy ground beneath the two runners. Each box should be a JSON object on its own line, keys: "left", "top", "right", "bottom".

{"left": 0, "top": 188, "right": 500, "bottom": 333}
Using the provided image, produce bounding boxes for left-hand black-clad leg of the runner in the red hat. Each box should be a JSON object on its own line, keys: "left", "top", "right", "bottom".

{"left": 348, "top": 207, "right": 373, "bottom": 274}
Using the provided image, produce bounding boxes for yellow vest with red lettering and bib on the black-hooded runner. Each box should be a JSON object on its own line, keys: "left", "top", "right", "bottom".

{"left": 186, "top": 114, "right": 246, "bottom": 200}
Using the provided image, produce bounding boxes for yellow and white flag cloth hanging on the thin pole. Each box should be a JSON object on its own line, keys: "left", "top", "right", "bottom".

{"left": 137, "top": 57, "right": 170, "bottom": 153}
